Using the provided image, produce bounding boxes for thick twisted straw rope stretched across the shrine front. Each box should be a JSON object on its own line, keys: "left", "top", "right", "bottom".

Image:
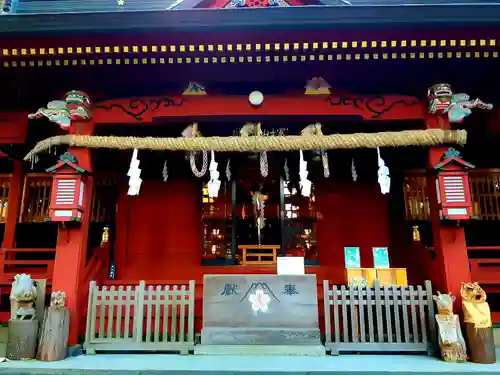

{"left": 24, "top": 129, "right": 467, "bottom": 160}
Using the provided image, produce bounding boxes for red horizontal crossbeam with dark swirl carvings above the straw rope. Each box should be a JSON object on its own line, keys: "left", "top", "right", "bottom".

{"left": 93, "top": 95, "right": 426, "bottom": 124}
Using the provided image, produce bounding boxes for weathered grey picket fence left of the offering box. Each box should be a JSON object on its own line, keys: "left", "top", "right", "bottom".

{"left": 84, "top": 280, "right": 195, "bottom": 354}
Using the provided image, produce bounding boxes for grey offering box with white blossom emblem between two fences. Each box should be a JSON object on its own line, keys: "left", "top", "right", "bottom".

{"left": 197, "top": 275, "right": 324, "bottom": 354}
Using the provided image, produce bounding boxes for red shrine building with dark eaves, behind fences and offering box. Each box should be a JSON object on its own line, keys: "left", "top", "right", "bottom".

{"left": 0, "top": 0, "right": 500, "bottom": 352}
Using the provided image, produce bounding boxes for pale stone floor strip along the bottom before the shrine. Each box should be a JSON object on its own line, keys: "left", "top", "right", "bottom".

{"left": 0, "top": 352, "right": 500, "bottom": 375}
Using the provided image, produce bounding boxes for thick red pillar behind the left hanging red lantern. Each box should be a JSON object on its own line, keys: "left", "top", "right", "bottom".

{"left": 52, "top": 122, "right": 94, "bottom": 345}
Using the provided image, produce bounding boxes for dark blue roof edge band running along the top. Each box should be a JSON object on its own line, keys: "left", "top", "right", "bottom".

{"left": 0, "top": 4, "right": 500, "bottom": 35}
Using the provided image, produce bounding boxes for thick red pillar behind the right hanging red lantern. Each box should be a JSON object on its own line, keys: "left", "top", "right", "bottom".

{"left": 426, "top": 116, "right": 470, "bottom": 310}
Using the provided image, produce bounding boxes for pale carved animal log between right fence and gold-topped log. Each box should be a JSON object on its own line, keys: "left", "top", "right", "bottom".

{"left": 433, "top": 292, "right": 467, "bottom": 362}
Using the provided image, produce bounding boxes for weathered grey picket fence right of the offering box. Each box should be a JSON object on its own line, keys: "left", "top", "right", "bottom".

{"left": 323, "top": 280, "right": 436, "bottom": 355}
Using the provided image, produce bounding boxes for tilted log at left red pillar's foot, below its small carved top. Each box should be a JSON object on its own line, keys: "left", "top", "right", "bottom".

{"left": 36, "top": 306, "right": 69, "bottom": 362}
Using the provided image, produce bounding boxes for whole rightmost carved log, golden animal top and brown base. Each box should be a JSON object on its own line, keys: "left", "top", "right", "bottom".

{"left": 460, "top": 283, "right": 496, "bottom": 363}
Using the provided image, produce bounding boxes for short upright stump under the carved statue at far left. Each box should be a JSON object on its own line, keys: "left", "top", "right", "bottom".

{"left": 7, "top": 320, "right": 38, "bottom": 360}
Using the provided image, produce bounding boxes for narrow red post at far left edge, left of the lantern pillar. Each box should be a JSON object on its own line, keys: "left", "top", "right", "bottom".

{"left": 2, "top": 160, "right": 24, "bottom": 249}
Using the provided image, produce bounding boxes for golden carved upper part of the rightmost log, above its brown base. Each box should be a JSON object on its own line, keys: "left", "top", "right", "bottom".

{"left": 460, "top": 283, "right": 492, "bottom": 328}
